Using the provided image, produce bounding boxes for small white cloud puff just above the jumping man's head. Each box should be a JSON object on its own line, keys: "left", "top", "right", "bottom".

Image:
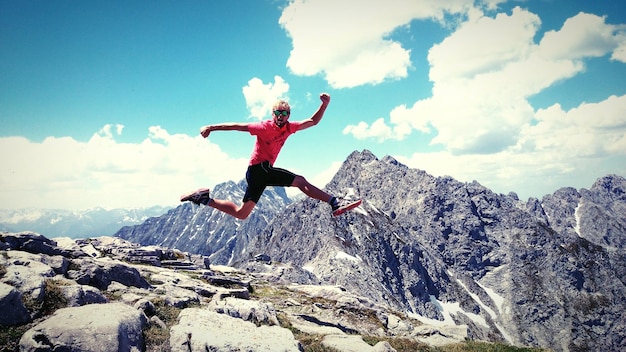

{"left": 243, "top": 76, "right": 289, "bottom": 120}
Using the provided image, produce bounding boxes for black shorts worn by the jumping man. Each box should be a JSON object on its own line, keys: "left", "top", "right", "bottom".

{"left": 243, "top": 161, "right": 296, "bottom": 203}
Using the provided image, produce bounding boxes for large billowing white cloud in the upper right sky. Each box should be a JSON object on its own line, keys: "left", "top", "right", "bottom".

{"left": 344, "top": 8, "right": 624, "bottom": 154}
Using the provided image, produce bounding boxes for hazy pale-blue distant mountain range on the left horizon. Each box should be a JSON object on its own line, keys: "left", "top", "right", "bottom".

{"left": 0, "top": 207, "right": 170, "bottom": 238}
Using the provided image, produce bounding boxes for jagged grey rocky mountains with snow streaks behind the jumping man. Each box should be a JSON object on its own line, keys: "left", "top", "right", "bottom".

{"left": 117, "top": 151, "right": 626, "bottom": 351}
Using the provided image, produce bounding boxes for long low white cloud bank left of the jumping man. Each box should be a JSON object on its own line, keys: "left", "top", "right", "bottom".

{"left": 0, "top": 125, "right": 247, "bottom": 209}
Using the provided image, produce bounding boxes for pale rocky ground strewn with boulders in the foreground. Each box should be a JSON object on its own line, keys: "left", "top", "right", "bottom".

{"left": 0, "top": 233, "right": 544, "bottom": 351}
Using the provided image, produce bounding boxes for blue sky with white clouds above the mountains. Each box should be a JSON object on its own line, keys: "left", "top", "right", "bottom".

{"left": 0, "top": 0, "right": 626, "bottom": 209}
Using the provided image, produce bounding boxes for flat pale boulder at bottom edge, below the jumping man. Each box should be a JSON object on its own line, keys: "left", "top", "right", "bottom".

{"left": 170, "top": 308, "right": 301, "bottom": 352}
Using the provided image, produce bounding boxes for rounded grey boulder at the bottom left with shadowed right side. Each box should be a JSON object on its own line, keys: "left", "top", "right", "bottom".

{"left": 20, "top": 303, "right": 148, "bottom": 352}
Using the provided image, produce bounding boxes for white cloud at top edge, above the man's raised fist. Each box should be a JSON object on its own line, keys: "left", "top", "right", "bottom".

{"left": 279, "top": 0, "right": 473, "bottom": 88}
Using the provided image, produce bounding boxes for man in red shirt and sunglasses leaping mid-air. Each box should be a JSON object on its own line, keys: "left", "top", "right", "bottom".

{"left": 180, "top": 93, "right": 361, "bottom": 220}
